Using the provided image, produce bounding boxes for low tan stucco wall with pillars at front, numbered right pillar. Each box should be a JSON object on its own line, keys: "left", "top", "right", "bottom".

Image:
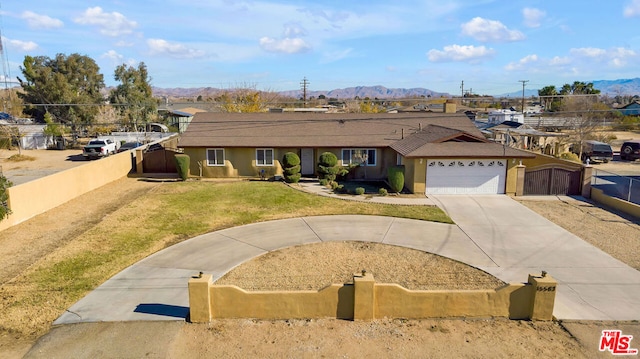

{"left": 189, "top": 274, "right": 557, "bottom": 322}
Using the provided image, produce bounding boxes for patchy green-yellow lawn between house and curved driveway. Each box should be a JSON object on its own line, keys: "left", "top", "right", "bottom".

{"left": 0, "top": 181, "right": 451, "bottom": 334}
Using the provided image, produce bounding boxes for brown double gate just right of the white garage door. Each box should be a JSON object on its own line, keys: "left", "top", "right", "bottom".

{"left": 524, "top": 167, "right": 582, "bottom": 195}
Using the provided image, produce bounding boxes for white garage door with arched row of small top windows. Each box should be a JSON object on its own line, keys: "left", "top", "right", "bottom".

{"left": 426, "top": 159, "right": 507, "bottom": 194}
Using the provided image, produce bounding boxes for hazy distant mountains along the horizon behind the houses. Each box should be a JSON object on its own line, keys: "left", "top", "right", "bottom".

{"left": 152, "top": 78, "right": 640, "bottom": 99}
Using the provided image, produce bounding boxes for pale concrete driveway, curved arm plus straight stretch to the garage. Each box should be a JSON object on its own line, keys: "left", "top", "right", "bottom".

{"left": 54, "top": 196, "right": 640, "bottom": 324}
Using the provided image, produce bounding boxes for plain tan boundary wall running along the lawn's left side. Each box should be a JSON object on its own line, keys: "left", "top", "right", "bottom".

{"left": 0, "top": 151, "right": 131, "bottom": 230}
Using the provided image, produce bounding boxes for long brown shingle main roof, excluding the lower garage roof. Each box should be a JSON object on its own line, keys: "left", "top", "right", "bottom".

{"left": 179, "top": 112, "right": 482, "bottom": 148}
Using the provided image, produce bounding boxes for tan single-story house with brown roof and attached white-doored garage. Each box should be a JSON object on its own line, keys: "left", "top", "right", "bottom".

{"left": 178, "top": 112, "right": 535, "bottom": 194}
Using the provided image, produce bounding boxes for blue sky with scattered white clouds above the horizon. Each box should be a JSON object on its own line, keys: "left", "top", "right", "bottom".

{"left": 0, "top": 0, "right": 640, "bottom": 95}
